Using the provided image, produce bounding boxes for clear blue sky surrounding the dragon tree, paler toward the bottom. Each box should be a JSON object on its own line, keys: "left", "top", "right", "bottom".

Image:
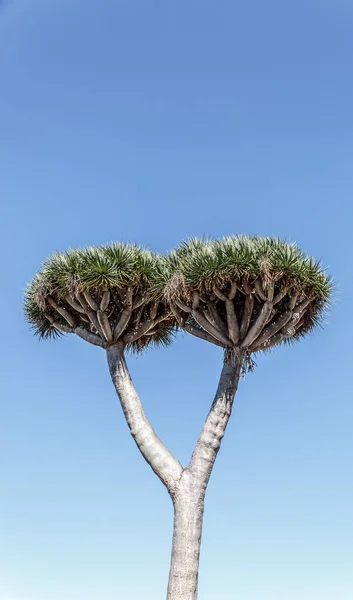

{"left": 0, "top": 0, "right": 353, "bottom": 600}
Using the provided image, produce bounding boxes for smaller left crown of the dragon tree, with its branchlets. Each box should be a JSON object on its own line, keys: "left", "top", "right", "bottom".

{"left": 24, "top": 243, "right": 175, "bottom": 351}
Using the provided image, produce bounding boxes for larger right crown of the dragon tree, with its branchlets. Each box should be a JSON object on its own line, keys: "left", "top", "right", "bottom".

{"left": 158, "top": 236, "right": 332, "bottom": 353}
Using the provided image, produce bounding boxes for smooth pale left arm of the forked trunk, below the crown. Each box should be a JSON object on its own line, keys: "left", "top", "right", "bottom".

{"left": 107, "top": 346, "right": 183, "bottom": 496}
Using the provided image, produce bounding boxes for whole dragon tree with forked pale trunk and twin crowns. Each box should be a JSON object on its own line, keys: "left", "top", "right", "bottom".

{"left": 24, "top": 236, "right": 332, "bottom": 600}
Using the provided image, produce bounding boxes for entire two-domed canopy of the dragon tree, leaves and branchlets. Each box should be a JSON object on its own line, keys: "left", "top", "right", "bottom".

{"left": 24, "top": 235, "right": 332, "bottom": 353}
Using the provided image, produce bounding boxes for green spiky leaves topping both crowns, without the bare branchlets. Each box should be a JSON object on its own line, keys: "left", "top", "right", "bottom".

{"left": 24, "top": 235, "right": 333, "bottom": 351}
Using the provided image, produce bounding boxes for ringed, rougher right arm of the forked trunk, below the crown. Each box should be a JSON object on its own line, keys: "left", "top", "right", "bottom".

{"left": 188, "top": 354, "right": 243, "bottom": 489}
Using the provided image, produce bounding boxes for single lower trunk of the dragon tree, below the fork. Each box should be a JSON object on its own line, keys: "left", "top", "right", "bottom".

{"left": 167, "top": 469, "right": 204, "bottom": 600}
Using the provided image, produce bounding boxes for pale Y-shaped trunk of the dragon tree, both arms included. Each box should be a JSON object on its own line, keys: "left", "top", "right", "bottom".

{"left": 107, "top": 346, "right": 243, "bottom": 600}
